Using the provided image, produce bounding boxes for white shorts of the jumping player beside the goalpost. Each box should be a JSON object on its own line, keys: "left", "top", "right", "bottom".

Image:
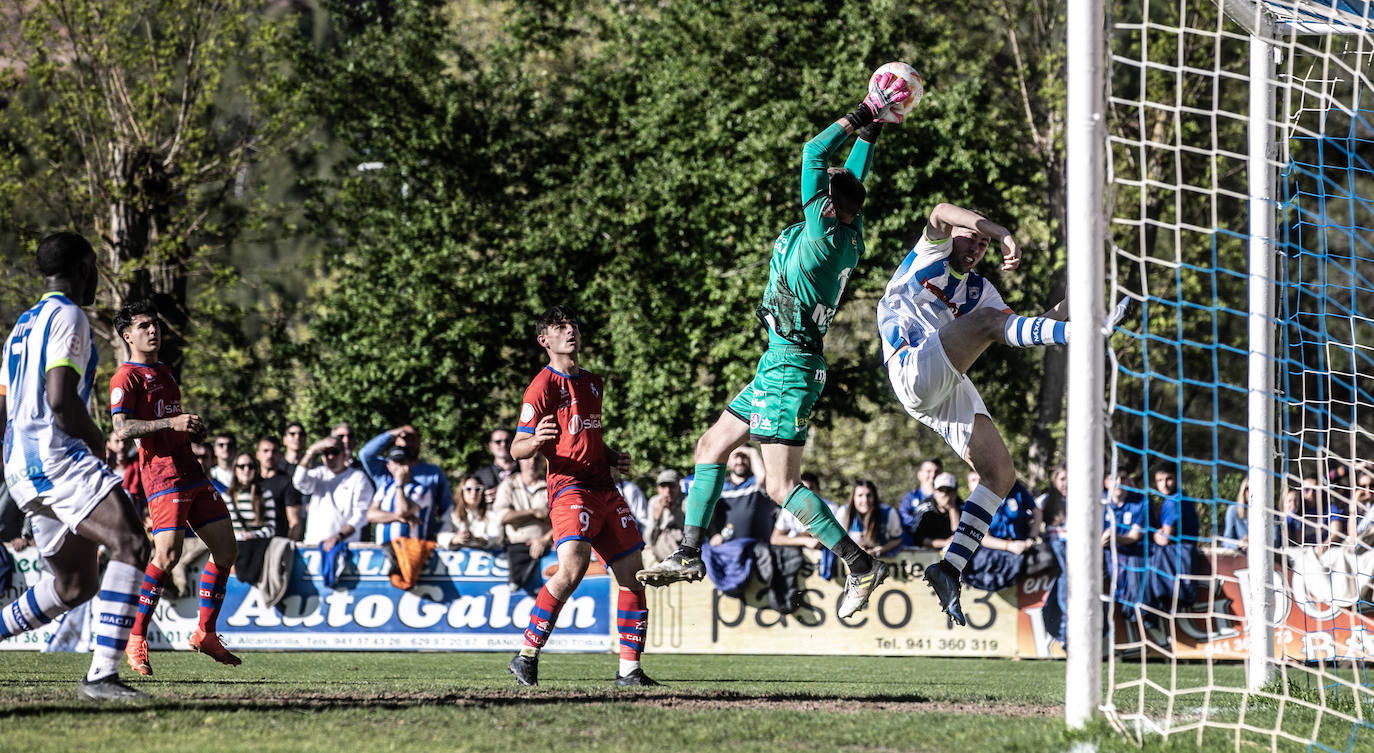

{"left": 888, "top": 334, "right": 992, "bottom": 458}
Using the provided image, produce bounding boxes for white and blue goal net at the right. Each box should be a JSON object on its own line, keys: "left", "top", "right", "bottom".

{"left": 1099, "top": 0, "right": 1374, "bottom": 753}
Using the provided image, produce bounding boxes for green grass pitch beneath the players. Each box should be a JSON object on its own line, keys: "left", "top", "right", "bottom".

{"left": 0, "top": 651, "right": 1374, "bottom": 753}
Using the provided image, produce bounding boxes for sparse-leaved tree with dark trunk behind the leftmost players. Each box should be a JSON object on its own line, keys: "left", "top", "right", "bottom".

{"left": 0, "top": 0, "right": 300, "bottom": 373}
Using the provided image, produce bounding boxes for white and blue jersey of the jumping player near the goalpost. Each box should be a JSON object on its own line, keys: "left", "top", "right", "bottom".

{"left": 878, "top": 234, "right": 1011, "bottom": 363}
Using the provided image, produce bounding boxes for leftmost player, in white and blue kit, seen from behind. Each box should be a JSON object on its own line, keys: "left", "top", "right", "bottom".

{"left": 0, "top": 232, "right": 148, "bottom": 701}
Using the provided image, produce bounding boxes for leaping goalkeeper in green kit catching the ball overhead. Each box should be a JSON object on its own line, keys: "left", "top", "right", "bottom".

{"left": 636, "top": 73, "right": 918, "bottom": 617}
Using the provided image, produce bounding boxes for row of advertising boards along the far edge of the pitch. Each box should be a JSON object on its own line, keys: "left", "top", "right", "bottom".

{"left": 0, "top": 547, "right": 1374, "bottom": 661}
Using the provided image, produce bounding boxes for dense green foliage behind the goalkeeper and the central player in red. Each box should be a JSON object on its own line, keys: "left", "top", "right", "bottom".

{"left": 298, "top": 1, "right": 1052, "bottom": 489}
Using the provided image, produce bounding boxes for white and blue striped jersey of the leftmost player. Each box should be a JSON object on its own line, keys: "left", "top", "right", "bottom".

{"left": 0, "top": 293, "right": 99, "bottom": 504}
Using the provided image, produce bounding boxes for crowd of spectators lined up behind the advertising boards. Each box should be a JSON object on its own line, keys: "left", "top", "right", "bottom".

{"left": 0, "top": 422, "right": 1374, "bottom": 639}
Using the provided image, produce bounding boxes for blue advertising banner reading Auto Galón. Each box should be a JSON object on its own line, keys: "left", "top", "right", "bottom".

{"left": 0, "top": 546, "right": 614, "bottom": 651}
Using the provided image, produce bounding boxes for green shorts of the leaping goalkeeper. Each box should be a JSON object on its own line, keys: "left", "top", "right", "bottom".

{"left": 725, "top": 345, "right": 826, "bottom": 445}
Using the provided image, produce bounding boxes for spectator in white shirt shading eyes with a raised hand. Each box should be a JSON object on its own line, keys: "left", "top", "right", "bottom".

{"left": 291, "top": 437, "right": 374, "bottom": 550}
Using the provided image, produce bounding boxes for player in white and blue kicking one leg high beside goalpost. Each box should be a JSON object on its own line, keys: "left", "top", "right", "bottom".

{"left": 878, "top": 203, "right": 1124, "bottom": 625}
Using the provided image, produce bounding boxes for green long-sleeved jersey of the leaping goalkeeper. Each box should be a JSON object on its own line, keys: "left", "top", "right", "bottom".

{"left": 757, "top": 118, "right": 872, "bottom": 353}
